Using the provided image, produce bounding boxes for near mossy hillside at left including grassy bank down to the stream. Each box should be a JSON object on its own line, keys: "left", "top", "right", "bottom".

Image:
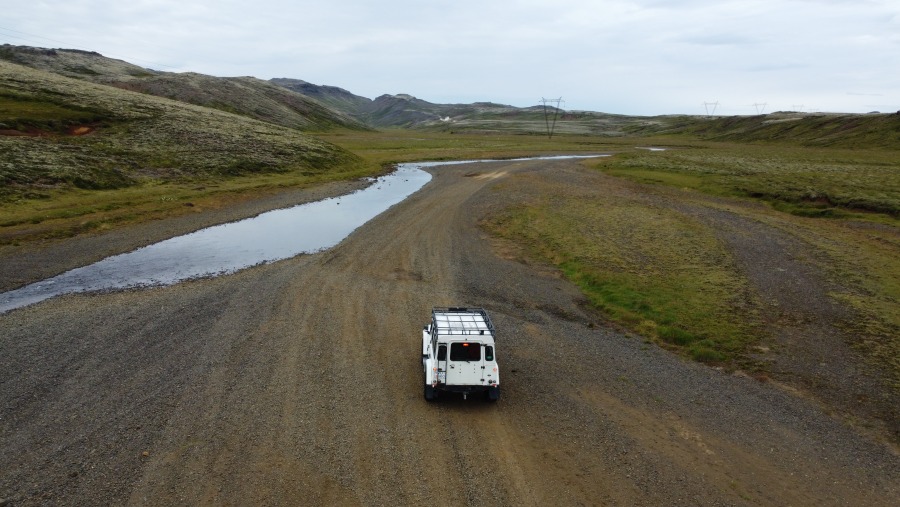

{"left": 0, "top": 62, "right": 368, "bottom": 243}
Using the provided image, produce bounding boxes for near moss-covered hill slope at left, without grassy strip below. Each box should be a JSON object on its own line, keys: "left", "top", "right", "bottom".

{"left": 0, "top": 60, "right": 358, "bottom": 199}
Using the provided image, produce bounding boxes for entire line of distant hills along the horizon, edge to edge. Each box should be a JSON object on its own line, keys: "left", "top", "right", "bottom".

{"left": 0, "top": 44, "right": 900, "bottom": 147}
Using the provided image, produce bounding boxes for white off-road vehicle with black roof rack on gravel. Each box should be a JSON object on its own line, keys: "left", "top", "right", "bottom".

{"left": 422, "top": 307, "right": 500, "bottom": 401}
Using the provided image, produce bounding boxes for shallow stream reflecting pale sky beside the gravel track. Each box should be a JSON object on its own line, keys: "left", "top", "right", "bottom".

{"left": 0, "top": 155, "right": 604, "bottom": 313}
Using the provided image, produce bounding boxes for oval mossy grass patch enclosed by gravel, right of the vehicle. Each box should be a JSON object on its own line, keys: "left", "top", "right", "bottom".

{"left": 484, "top": 179, "right": 758, "bottom": 364}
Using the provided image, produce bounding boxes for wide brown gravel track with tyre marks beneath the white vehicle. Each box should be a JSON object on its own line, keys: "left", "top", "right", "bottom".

{"left": 0, "top": 161, "right": 900, "bottom": 506}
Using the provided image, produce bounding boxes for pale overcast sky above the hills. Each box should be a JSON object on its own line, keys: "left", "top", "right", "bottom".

{"left": 0, "top": 0, "right": 900, "bottom": 115}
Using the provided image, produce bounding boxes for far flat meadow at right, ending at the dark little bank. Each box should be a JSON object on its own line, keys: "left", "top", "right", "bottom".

{"left": 598, "top": 143, "right": 900, "bottom": 222}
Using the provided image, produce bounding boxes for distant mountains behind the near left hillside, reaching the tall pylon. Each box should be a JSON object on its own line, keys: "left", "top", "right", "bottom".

{"left": 0, "top": 44, "right": 630, "bottom": 133}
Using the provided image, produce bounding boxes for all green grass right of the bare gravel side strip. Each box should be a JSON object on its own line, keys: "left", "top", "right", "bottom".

{"left": 595, "top": 141, "right": 900, "bottom": 387}
